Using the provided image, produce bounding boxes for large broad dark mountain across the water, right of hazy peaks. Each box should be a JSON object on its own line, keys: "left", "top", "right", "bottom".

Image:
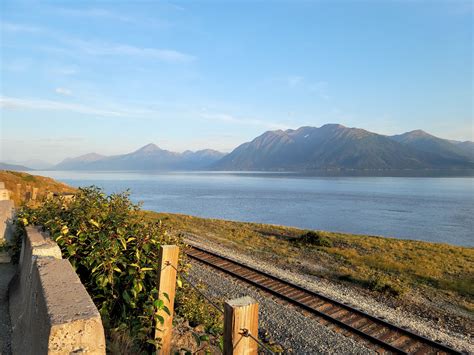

{"left": 212, "top": 124, "right": 474, "bottom": 171}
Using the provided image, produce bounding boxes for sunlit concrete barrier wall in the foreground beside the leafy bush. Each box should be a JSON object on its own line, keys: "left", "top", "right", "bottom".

{"left": 9, "top": 227, "right": 105, "bottom": 355}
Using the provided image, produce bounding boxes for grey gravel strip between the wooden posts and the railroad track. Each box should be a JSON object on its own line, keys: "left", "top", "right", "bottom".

{"left": 189, "top": 261, "right": 374, "bottom": 354}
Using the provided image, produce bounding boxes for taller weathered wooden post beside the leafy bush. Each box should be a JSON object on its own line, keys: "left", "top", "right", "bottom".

{"left": 155, "top": 245, "right": 179, "bottom": 355}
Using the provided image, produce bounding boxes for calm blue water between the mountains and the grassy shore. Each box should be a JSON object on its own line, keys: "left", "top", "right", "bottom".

{"left": 31, "top": 171, "right": 474, "bottom": 246}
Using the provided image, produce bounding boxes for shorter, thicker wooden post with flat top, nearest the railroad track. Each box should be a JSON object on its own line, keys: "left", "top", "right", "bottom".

{"left": 224, "top": 296, "right": 258, "bottom": 355}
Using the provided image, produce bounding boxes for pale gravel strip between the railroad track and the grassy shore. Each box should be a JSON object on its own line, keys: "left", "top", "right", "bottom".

{"left": 186, "top": 235, "right": 474, "bottom": 354}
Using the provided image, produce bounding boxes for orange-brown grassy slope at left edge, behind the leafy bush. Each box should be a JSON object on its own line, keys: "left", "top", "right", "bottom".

{"left": 0, "top": 170, "right": 75, "bottom": 206}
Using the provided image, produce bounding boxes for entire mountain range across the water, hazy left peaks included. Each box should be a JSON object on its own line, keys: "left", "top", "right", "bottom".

{"left": 0, "top": 124, "right": 474, "bottom": 175}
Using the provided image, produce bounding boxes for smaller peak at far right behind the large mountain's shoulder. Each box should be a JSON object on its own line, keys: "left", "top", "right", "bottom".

{"left": 390, "top": 130, "right": 474, "bottom": 161}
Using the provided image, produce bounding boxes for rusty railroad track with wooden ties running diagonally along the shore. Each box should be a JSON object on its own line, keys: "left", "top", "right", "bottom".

{"left": 186, "top": 246, "right": 462, "bottom": 355}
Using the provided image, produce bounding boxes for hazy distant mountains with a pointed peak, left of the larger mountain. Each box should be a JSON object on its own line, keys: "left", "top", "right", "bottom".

{"left": 54, "top": 143, "right": 224, "bottom": 170}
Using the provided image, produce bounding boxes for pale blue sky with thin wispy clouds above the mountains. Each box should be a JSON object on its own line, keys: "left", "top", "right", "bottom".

{"left": 0, "top": 0, "right": 474, "bottom": 163}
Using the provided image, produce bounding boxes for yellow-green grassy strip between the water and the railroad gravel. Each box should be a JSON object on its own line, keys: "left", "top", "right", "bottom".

{"left": 146, "top": 212, "right": 474, "bottom": 312}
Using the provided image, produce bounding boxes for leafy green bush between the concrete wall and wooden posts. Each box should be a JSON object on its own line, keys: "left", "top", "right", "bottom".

{"left": 18, "top": 187, "right": 184, "bottom": 351}
